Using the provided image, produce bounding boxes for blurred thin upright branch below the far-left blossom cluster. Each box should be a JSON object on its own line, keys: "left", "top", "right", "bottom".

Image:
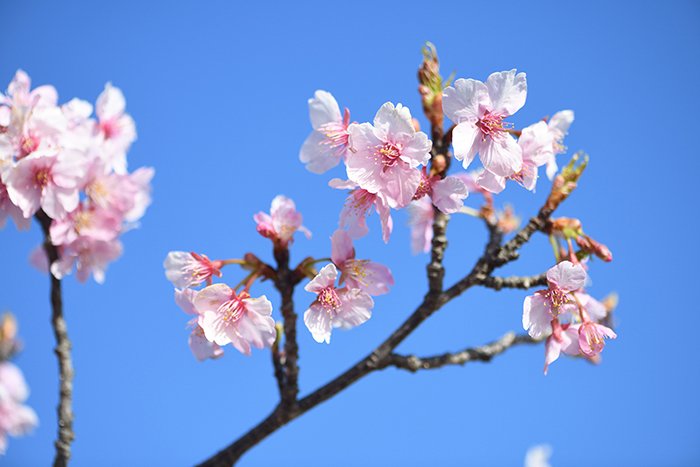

{"left": 36, "top": 211, "right": 75, "bottom": 467}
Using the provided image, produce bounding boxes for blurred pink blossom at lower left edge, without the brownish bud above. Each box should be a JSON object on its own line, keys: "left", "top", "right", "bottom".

{"left": 0, "top": 362, "right": 39, "bottom": 454}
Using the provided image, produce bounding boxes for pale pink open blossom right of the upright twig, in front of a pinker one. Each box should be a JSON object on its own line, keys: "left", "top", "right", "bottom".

{"left": 304, "top": 264, "right": 374, "bottom": 344}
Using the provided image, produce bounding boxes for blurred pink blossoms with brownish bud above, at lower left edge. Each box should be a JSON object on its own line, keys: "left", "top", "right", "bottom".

{"left": 0, "top": 313, "right": 39, "bottom": 454}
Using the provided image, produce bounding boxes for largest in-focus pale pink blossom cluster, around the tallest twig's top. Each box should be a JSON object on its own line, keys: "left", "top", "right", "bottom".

{"left": 299, "top": 70, "right": 574, "bottom": 253}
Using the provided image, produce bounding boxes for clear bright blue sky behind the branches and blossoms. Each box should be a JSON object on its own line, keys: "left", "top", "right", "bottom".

{"left": 0, "top": 0, "right": 700, "bottom": 467}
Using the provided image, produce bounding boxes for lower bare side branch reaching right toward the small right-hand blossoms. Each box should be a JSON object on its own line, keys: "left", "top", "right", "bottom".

{"left": 385, "top": 332, "right": 539, "bottom": 372}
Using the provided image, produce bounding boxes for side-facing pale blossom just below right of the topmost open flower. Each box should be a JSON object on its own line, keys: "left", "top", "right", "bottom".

{"left": 477, "top": 121, "right": 554, "bottom": 193}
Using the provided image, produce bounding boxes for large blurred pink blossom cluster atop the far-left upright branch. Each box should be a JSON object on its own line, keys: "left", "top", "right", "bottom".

{"left": 0, "top": 70, "right": 153, "bottom": 283}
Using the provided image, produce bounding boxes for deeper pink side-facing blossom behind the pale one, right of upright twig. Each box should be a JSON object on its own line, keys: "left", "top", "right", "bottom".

{"left": 331, "top": 230, "right": 394, "bottom": 295}
